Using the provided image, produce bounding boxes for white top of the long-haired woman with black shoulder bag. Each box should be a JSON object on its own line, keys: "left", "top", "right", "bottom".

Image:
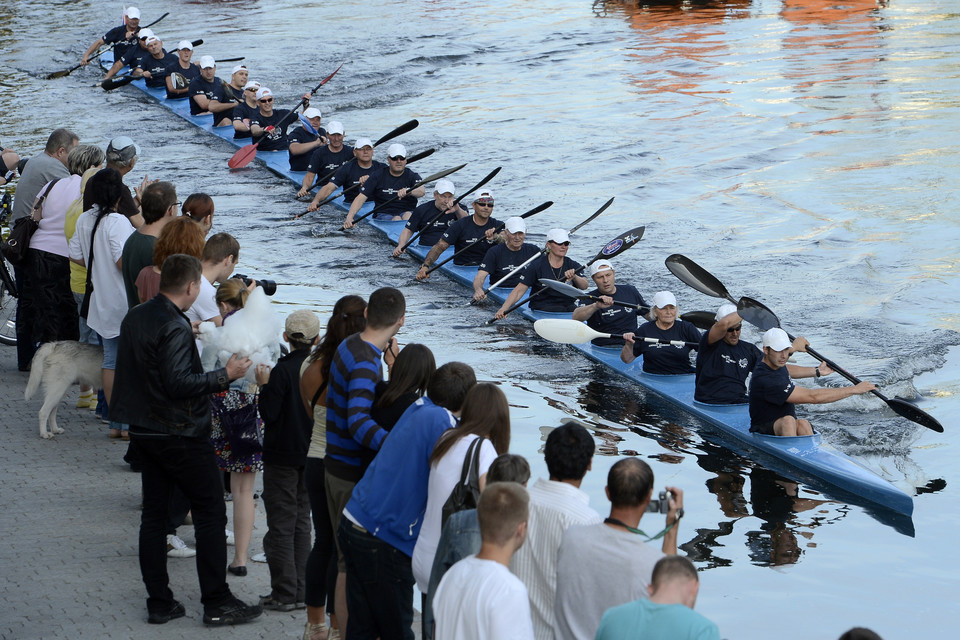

{"left": 413, "top": 434, "right": 497, "bottom": 593}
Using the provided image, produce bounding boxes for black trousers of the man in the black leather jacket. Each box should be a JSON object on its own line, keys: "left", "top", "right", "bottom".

{"left": 130, "top": 431, "right": 232, "bottom": 612}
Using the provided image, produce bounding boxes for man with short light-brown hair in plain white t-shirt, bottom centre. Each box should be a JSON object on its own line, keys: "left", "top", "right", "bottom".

{"left": 433, "top": 482, "right": 533, "bottom": 640}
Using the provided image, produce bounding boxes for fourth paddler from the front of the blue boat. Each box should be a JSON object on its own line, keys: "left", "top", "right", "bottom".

{"left": 573, "top": 260, "right": 647, "bottom": 347}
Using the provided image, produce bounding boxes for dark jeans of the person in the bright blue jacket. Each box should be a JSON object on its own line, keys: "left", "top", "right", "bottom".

{"left": 337, "top": 516, "right": 414, "bottom": 640}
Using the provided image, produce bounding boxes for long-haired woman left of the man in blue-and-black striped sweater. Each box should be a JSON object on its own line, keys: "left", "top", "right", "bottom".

{"left": 300, "top": 295, "right": 367, "bottom": 640}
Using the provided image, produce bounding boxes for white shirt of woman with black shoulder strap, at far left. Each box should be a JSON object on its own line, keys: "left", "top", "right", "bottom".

{"left": 70, "top": 207, "right": 134, "bottom": 339}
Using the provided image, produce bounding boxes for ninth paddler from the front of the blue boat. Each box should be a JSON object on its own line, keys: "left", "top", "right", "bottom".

{"left": 343, "top": 142, "right": 427, "bottom": 229}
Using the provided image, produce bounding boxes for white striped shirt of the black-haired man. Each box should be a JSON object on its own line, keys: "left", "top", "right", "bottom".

{"left": 510, "top": 478, "right": 603, "bottom": 640}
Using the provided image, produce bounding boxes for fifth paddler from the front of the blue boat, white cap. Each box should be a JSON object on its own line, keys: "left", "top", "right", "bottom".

{"left": 494, "top": 229, "right": 589, "bottom": 320}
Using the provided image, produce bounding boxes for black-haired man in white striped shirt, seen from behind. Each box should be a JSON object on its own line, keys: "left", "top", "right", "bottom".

{"left": 510, "top": 421, "right": 601, "bottom": 640}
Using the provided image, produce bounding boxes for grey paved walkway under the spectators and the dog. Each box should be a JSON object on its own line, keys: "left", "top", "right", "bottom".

{"left": 0, "top": 346, "right": 420, "bottom": 640}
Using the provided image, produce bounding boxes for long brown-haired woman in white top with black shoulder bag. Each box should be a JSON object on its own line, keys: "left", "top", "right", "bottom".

{"left": 413, "top": 382, "right": 510, "bottom": 594}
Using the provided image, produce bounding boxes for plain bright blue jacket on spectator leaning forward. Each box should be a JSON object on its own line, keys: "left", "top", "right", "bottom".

{"left": 346, "top": 398, "right": 457, "bottom": 557}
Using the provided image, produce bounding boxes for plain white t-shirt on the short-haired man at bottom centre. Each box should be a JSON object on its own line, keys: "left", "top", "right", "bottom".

{"left": 433, "top": 547, "right": 533, "bottom": 640}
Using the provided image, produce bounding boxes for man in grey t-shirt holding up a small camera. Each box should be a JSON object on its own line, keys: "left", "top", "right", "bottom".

{"left": 554, "top": 458, "right": 683, "bottom": 640}
